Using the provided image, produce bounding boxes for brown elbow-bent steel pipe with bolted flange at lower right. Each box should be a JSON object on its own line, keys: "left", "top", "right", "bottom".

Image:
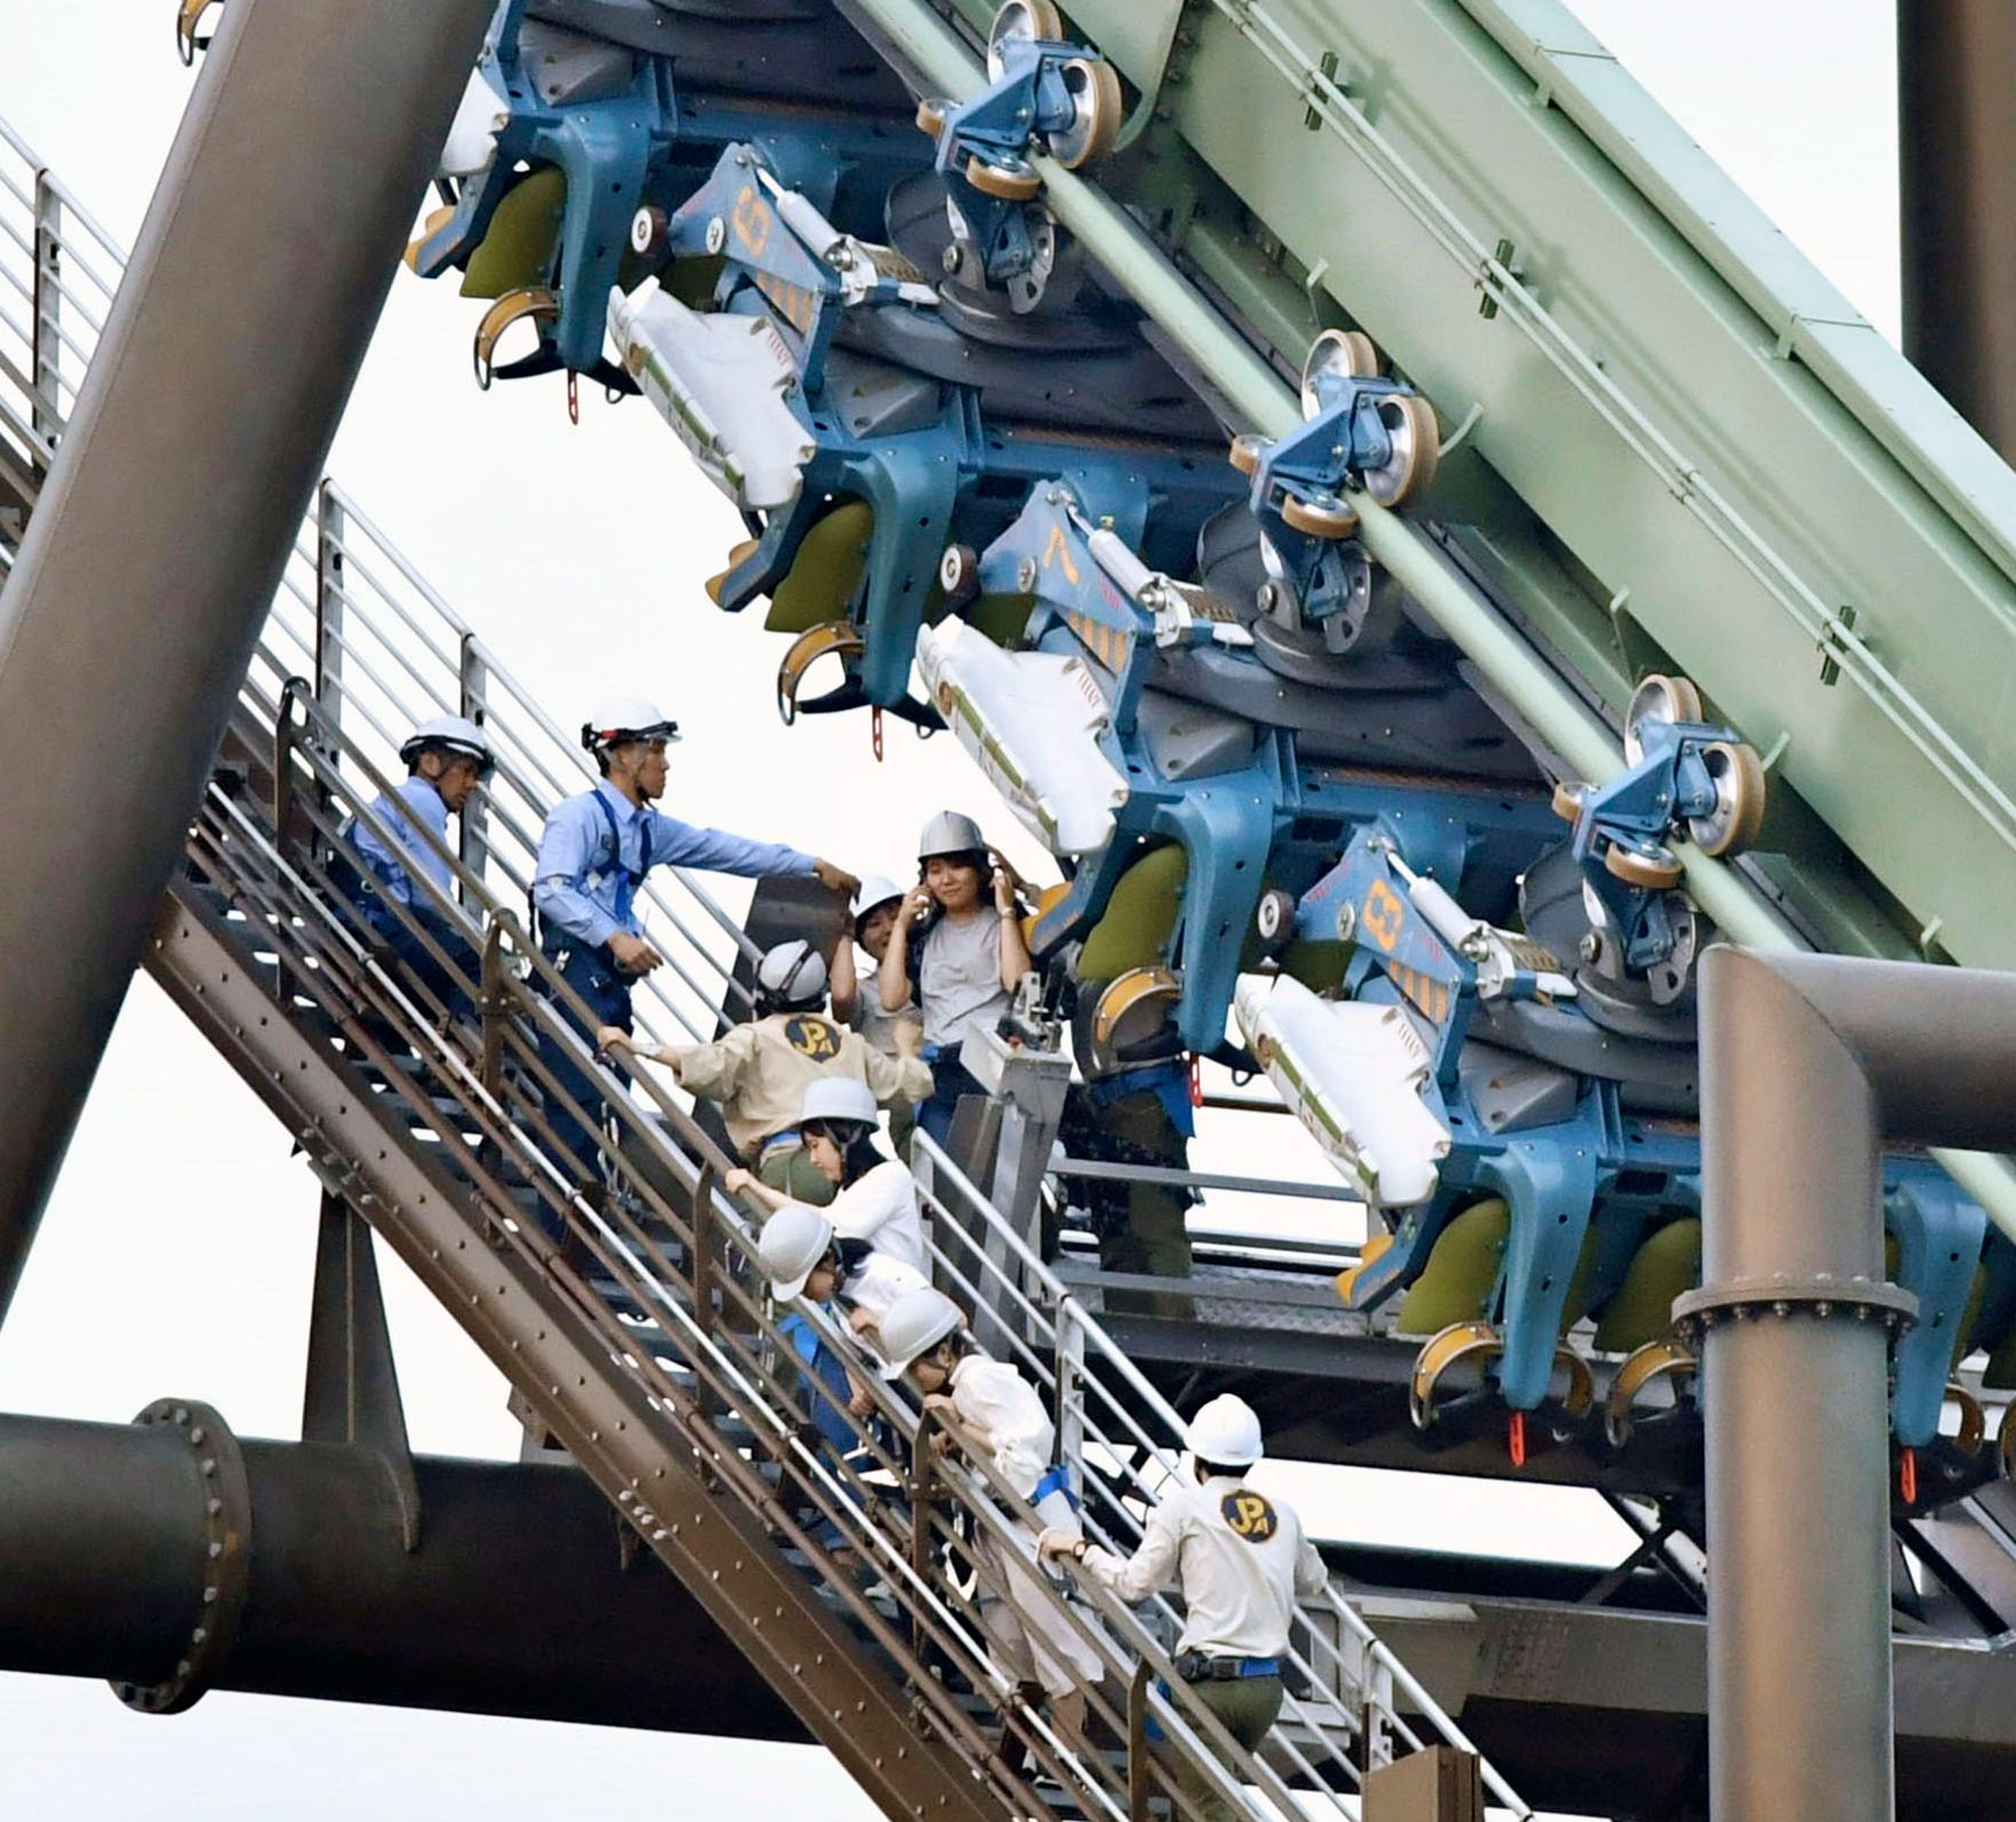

{"left": 1673, "top": 947, "right": 2016, "bottom": 1822}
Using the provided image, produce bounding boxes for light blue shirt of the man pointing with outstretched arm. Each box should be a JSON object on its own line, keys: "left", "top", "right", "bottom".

{"left": 532, "top": 778, "right": 814, "bottom": 950}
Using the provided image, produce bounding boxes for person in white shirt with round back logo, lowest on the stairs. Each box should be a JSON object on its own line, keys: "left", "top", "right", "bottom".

{"left": 1039, "top": 1395, "right": 1329, "bottom": 1822}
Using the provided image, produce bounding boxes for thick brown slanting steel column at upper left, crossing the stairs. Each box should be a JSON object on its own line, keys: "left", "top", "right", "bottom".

{"left": 0, "top": 0, "right": 492, "bottom": 1314}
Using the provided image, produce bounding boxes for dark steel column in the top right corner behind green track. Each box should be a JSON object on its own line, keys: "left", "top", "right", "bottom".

{"left": 1897, "top": 0, "right": 2016, "bottom": 462}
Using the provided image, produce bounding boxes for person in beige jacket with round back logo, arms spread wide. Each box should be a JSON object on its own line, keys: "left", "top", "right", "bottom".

{"left": 595, "top": 939, "right": 931, "bottom": 1208}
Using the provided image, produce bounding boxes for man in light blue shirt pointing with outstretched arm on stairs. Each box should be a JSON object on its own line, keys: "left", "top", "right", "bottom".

{"left": 532, "top": 696, "right": 859, "bottom": 1209}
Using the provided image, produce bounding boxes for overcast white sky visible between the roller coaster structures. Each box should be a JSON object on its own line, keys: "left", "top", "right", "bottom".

{"left": 0, "top": 0, "right": 1897, "bottom": 1822}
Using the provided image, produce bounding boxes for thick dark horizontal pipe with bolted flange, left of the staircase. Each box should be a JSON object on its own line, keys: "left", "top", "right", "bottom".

{"left": 0, "top": 1407, "right": 805, "bottom": 1740}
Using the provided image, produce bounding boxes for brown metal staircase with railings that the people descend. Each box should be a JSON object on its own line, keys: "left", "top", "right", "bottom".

{"left": 0, "top": 110, "right": 1528, "bottom": 1818}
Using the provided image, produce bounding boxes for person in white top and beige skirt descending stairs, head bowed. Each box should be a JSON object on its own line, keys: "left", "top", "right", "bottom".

{"left": 877, "top": 1290, "right": 1105, "bottom": 1733}
